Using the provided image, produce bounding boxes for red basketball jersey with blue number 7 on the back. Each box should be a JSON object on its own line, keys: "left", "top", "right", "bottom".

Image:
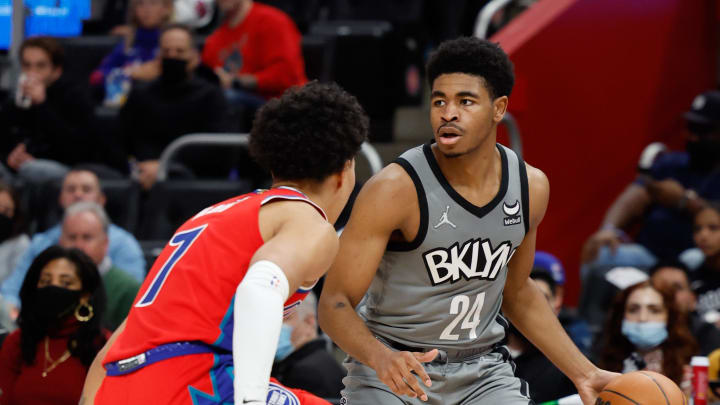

{"left": 103, "top": 187, "right": 325, "bottom": 364}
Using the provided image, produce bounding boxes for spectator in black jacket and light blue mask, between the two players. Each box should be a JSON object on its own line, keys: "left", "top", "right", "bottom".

{"left": 272, "top": 293, "right": 345, "bottom": 398}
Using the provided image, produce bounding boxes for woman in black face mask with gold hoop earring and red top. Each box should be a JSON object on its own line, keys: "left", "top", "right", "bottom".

{"left": 0, "top": 246, "right": 108, "bottom": 405}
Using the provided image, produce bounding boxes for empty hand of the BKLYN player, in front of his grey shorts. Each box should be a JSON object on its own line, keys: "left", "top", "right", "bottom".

{"left": 371, "top": 349, "right": 438, "bottom": 401}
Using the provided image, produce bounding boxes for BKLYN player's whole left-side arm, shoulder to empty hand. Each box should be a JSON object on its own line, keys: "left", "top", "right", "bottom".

{"left": 318, "top": 164, "right": 437, "bottom": 400}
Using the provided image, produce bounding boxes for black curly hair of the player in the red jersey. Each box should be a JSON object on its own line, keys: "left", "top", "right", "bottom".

{"left": 250, "top": 81, "right": 369, "bottom": 181}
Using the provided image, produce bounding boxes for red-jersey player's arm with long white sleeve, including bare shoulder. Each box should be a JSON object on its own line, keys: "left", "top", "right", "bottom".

{"left": 233, "top": 201, "right": 338, "bottom": 404}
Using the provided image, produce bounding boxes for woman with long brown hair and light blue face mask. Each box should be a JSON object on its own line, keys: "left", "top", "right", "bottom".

{"left": 600, "top": 281, "right": 698, "bottom": 390}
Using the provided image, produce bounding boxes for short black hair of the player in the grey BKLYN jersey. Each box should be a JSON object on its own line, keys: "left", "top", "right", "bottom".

{"left": 426, "top": 37, "right": 515, "bottom": 100}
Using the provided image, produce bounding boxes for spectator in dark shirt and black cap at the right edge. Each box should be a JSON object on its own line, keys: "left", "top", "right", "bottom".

{"left": 581, "top": 90, "right": 720, "bottom": 278}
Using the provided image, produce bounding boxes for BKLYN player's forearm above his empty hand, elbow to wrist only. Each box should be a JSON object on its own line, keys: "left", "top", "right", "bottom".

{"left": 318, "top": 293, "right": 390, "bottom": 367}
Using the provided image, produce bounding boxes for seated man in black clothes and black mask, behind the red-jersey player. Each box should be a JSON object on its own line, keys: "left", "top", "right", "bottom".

{"left": 120, "top": 24, "right": 226, "bottom": 189}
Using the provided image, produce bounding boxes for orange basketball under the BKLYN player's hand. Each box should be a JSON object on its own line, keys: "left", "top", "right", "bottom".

{"left": 595, "top": 371, "right": 687, "bottom": 405}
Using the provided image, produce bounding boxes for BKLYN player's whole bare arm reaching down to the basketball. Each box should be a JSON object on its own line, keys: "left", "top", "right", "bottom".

{"left": 503, "top": 165, "right": 616, "bottom": 405}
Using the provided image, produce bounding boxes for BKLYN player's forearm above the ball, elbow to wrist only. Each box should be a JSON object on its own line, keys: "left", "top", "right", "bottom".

{"left": 503, "top": 279, "right": 597, "bottom": 385}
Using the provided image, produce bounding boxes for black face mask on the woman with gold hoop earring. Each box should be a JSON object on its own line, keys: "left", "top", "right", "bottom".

{"left": 27, "top": 286, "right": 82, "bottom": 330}
